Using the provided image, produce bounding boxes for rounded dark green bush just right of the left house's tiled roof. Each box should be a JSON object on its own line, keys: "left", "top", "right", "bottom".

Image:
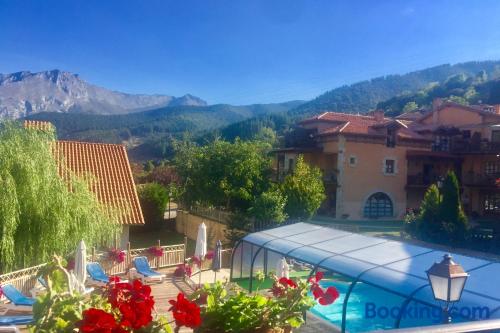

{"left": 137, "top": 183, "right": 169, "bottom": 229}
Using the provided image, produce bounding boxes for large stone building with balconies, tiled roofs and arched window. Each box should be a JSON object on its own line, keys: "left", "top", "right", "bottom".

{"left": 275, "top": 100, "right": 500, "bottom": 220}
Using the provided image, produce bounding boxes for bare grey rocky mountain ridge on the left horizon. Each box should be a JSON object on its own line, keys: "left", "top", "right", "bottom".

{"left": 0, "top": 69, "right": 207, "bottom": 119}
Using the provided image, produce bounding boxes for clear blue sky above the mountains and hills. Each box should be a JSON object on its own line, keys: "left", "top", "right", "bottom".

{"left": 0, "top": 0, "right": 500, "bottom": 104}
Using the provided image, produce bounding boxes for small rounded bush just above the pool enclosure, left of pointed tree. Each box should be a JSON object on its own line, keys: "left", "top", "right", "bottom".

{"left": 250, "top": 187, "right": 287, "bottom": 223}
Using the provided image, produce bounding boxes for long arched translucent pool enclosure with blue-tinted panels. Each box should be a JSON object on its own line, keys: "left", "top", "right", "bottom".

{"left": 230, "top": 223, "right": 500, "bottom": 332}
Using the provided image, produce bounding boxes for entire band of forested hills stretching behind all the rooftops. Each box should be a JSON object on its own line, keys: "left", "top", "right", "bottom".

{"left": 12, "top": 61, "right": 500, "bottom": 160}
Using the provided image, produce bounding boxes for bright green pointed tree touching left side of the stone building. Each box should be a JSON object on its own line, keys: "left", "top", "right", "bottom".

{"left": 282, "top": 155, "right": 326, "bottom": 219}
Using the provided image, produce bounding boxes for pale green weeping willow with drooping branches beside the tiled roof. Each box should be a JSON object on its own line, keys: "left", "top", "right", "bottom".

{"left": 0, "top": 122, "right": 119, "bottom": 272}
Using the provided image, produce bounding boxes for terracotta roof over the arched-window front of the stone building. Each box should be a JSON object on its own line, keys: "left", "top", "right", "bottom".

{"left": 301, "top": 112, "right": 425, "bottom": 140}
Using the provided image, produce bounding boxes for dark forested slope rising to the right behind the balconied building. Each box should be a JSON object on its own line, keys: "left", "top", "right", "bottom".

{"left": 212, "top": 61, "right": 500, "bottom": 140}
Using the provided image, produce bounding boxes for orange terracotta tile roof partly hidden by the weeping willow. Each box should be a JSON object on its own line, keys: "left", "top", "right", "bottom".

{"left": 24, "top": 121, "right": 144, "bottom": 225}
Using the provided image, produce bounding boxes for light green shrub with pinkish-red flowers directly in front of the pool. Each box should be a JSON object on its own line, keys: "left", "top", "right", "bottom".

{"left": 192, "top": 272, "right": 339, "bottom": 333}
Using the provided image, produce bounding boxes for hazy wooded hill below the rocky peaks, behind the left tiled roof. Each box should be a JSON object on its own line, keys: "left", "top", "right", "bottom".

{"left": 26, "top": 101, "right": 303, "bottom": 143}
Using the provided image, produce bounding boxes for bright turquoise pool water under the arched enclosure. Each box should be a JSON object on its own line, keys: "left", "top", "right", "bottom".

{"left": 311, "top": 280, "right": 448, "bottom": 333}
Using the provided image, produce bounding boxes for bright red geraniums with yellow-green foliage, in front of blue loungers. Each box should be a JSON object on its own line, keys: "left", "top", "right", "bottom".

{"left": 30, "top": 260, "right": 172, "bottom": 333}
